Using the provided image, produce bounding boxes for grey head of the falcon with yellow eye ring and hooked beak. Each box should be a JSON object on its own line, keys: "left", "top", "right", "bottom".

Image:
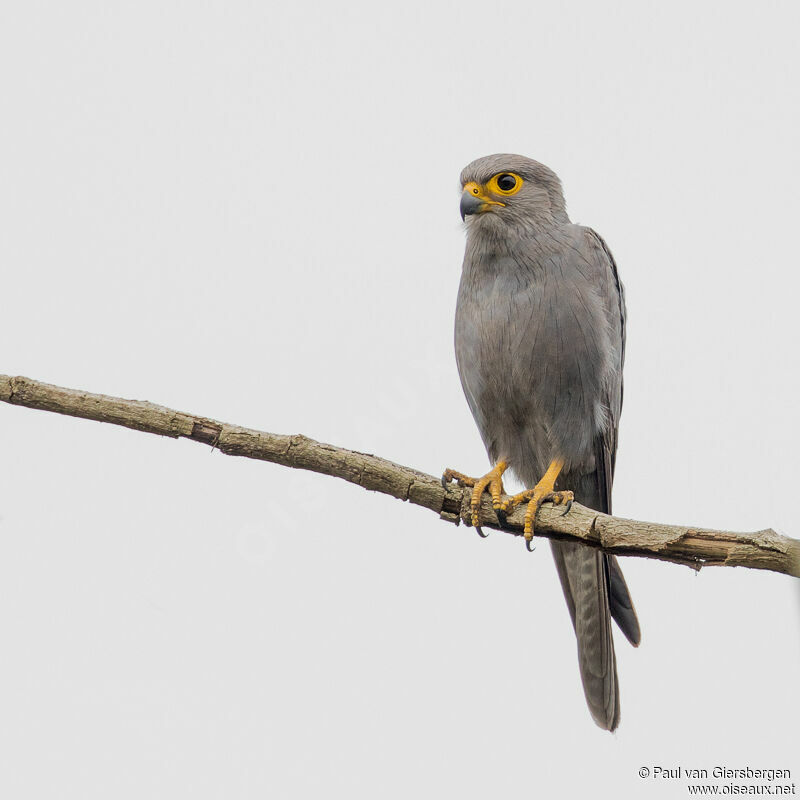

{"left": 461, "top": 153, "right": 569, "bottom": 231}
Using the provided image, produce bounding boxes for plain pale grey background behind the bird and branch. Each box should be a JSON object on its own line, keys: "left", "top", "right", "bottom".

{"left": 0, "top": 2, "right": 800, "bottom": 798}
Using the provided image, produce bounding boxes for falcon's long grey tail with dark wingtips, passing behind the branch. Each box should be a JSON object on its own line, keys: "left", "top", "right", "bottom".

{"left": 550, "top": 470, "right": 641, "bottom": 731}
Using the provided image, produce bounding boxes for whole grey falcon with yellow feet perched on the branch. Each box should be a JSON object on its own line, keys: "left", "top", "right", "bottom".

{"left": 443, "top": 153, "right": 641, "bottom": 731}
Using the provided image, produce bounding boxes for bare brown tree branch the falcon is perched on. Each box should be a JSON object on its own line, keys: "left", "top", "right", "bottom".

{"left": 0, "top": 375, "right": 800, "bottom": 577}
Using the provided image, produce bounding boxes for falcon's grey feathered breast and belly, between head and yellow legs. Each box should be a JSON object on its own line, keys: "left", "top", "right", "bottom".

{"left": 455, "top": 224, "right": 622, "bottom": 486}
